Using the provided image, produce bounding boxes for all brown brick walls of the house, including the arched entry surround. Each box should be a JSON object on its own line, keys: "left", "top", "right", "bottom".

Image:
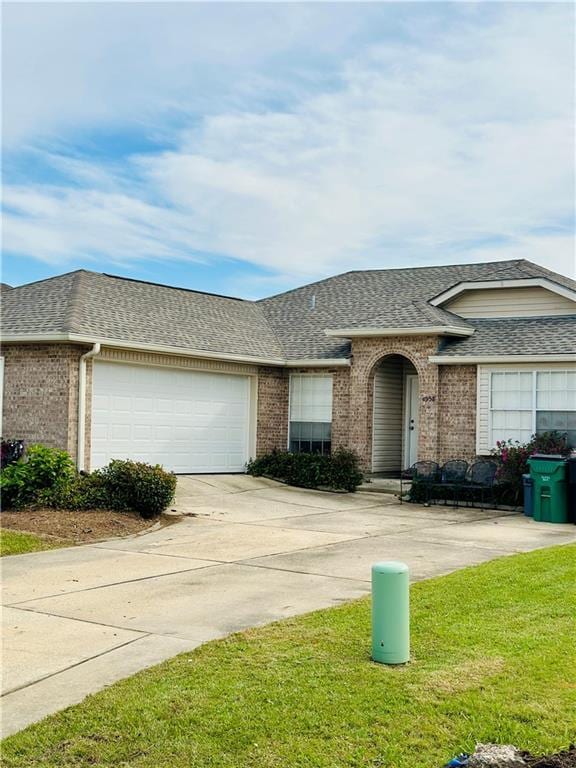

{"left": 2, "top": 336, "right": 476, "bottom": 471}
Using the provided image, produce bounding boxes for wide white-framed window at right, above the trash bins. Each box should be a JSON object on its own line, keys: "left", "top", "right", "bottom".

{"left": 490, "top": 370, "right": 576, "bottom": 447}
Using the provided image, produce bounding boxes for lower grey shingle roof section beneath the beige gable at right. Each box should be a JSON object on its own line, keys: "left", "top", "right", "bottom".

{"left": 438, "top": 314, "right": 576, "bottom": 361}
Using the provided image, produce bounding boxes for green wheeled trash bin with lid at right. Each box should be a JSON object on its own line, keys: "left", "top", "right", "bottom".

{"left": 528, "top": 454, "right": 568, "bottom": 523}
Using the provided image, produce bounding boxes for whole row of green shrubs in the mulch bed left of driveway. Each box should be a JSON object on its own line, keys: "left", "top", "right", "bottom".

{"left": 0, "top": 445, "right": 176, "bottom": 518}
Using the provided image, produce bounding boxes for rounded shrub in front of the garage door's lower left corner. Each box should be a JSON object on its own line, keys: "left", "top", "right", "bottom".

{"left": 98, "top": 459, "right": 176, "bottom": 518}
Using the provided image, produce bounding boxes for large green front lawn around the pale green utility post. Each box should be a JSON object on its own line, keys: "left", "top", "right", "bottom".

{"left": 3, "top": 546, "right": 576, "bottom": 768}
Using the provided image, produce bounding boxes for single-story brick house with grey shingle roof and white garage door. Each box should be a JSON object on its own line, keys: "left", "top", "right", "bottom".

{"left": 1, "top": 260, "right": 576, "bottom": 476}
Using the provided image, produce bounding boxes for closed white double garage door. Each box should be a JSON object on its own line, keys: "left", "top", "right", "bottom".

{"left": 91, "top": 361, "right": 250, "bottom": 472}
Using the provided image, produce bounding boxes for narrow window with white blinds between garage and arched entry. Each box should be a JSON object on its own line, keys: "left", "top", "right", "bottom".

{"left": 289, "top": 375, "right": 332, "bottom": 454}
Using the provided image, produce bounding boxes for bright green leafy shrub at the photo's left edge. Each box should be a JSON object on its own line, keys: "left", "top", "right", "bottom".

{"left": 0, "top": 445, "right": 76, "bottom": 507}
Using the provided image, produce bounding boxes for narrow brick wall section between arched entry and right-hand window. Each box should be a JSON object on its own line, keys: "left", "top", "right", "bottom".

{"left": 438, "top": 365, "right": 477, "bottom": 462}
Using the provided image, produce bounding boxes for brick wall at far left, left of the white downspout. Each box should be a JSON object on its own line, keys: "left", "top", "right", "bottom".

{"left": 2, "top": 344, "right": 86, "bottom": 457}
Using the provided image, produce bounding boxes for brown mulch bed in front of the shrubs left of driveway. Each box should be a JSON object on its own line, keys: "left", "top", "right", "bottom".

{"left": 0, "top": 509, "right": 155, "bottom": 544}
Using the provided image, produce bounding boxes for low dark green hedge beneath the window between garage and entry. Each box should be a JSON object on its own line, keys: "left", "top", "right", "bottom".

{"left": 246, "top": 448, "right": 363, "bottom": 491}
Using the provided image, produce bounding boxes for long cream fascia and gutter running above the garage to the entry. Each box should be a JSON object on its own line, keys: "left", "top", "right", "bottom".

{"left": 1, "top": 333, "right": 350, "bottom": 368}
